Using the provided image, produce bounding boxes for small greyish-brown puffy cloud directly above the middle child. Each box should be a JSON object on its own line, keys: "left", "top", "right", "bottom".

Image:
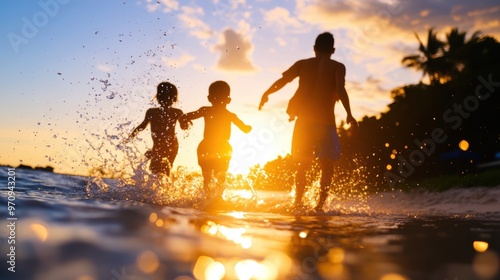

{"left": 214, "top": 29, "right": 255, "bottom": 72}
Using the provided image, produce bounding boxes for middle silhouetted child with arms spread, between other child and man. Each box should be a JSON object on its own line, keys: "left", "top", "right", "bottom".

{"left": 181, "top": 81, "right": 252, "bottom": 199}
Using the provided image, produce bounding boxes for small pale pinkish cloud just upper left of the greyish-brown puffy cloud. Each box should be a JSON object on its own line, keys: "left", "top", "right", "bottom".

{"left": 179, "top": 6, "right": 214, "bottom": 39}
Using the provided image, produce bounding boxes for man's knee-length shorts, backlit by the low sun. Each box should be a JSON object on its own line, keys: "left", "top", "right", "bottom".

{"left": 292, "top": 120, "right": 340, "bottom": 161}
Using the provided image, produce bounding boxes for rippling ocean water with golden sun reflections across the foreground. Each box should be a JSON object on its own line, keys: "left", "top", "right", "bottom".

{"left": 0, "top": 167, "right": 500, "bottom": 280}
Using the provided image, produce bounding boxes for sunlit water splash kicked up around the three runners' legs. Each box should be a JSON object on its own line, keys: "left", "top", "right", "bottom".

{"left": 87, "top": 118, "right": 376, "bottom": 214}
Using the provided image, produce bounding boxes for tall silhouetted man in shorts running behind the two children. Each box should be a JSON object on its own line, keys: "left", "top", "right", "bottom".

{"left": 259, "top": 32, "right": 357, "bottom": 211}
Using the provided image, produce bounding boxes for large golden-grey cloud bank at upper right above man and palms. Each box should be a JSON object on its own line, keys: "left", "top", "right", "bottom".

{"left": 294, "top": 0, "right": 500, "bottom": 92}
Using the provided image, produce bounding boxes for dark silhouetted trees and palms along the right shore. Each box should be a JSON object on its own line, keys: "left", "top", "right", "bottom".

{"left": 250, "top": 29, "right": 500, "bottom": 189}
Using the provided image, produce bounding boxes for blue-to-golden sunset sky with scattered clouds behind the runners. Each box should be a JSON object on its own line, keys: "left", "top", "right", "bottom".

{"left": 0, "top": 0, "right": 500, "bottom": 174}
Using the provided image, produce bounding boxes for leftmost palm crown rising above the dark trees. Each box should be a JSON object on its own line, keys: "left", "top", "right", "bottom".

{"left": 402, "top": 28, "right": 446, "bottom": 83}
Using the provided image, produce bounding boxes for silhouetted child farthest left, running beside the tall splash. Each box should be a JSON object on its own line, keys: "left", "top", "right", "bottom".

{"left": 129, "top": 82, "right": 188, "bottom": 176}
